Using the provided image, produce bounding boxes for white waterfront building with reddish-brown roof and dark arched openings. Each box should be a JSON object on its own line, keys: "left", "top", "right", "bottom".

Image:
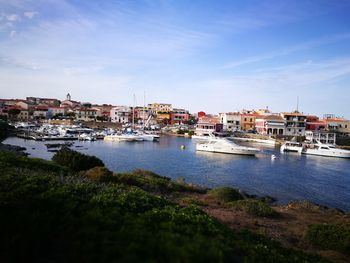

{"left": 255, "top": 115, "right": 285, "bottom": 135}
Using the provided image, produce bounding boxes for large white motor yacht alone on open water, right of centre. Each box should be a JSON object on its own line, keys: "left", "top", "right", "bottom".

{"left": 196, "top": 138, "right": 260, "bottom": 155}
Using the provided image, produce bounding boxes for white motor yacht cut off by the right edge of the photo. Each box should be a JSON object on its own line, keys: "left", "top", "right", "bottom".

{"left": 302, "top": 141, "right": 350, "bottom": 158}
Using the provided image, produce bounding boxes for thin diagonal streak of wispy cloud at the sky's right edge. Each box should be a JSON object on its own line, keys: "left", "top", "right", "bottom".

{"left": 223, "top": 33, "right": 350, "bottom": 68}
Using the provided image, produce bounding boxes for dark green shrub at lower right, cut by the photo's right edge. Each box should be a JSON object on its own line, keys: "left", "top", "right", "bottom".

{"left": 305, "top": 224, "right": 350, "bottom": 254}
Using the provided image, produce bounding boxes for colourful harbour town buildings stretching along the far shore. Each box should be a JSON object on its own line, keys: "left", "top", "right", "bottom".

{"left": 0, "top": 94, "right": 350, "bottom": 142}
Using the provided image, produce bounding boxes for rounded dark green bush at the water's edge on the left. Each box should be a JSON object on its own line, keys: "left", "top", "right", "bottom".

{"left": 52, "top": 147, "right": 104, "bottom": 172}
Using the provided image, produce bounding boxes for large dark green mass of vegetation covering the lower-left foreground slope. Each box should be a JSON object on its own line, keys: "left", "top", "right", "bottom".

{"left": 0, "top": 153, "right": 327, "bottom": 262}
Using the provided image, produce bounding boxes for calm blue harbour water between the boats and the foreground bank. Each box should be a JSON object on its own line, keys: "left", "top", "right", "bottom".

{"left": 4, "top": 137, "right": 350, "bottom": 211}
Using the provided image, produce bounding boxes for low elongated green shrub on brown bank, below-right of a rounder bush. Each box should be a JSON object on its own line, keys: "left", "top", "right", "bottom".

{"left": 227, "top": 199, "right": 278, "bottom": 217}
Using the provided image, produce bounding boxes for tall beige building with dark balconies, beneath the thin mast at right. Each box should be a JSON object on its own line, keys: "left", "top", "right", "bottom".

{"left": 281, "top": 111, "right": 306, "bottom": 136}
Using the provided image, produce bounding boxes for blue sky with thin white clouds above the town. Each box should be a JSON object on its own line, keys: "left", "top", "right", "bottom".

{"left": 0, "top": 0, "right": 350, "bottom": 119}
